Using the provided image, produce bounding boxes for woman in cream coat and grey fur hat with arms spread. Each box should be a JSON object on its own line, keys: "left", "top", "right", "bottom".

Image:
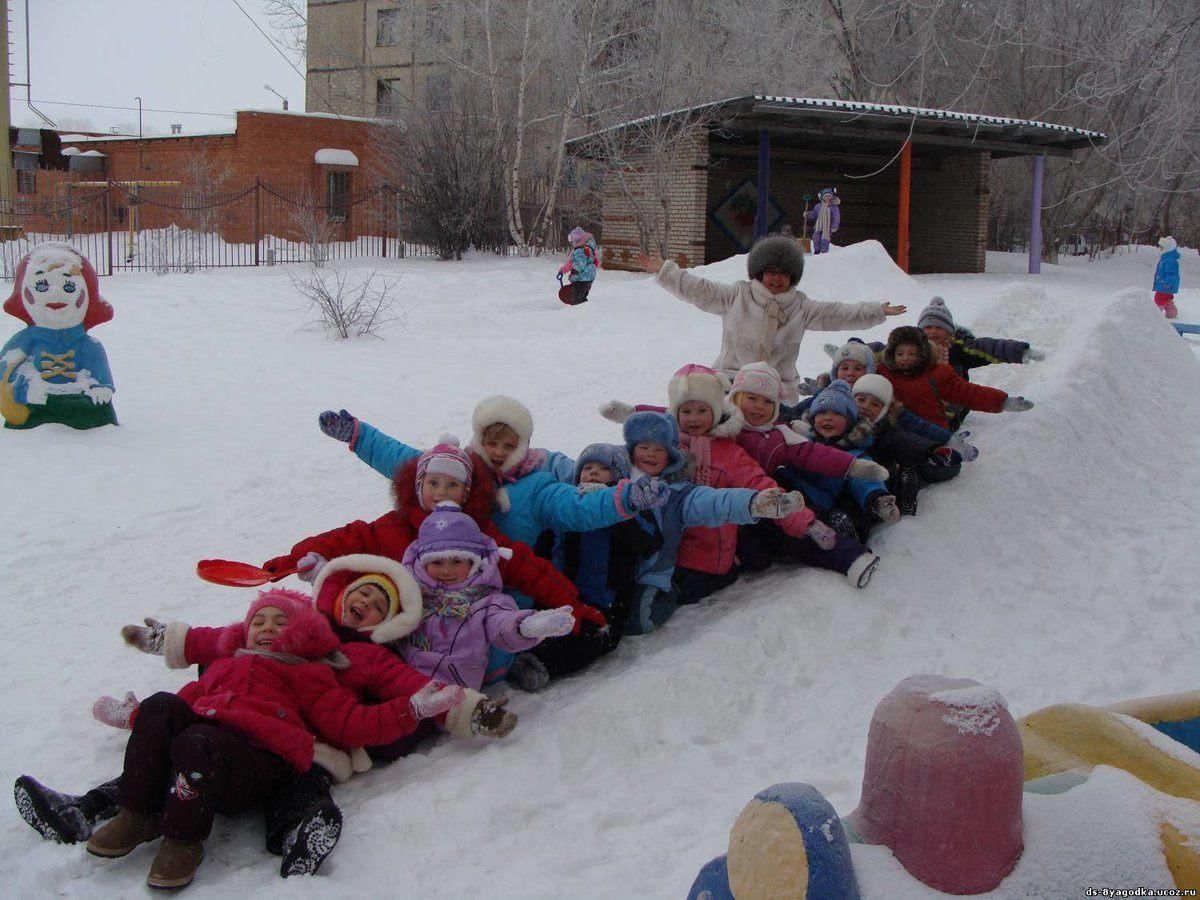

{"left": 637, "top": 234, "right": 907, "bottom": 403}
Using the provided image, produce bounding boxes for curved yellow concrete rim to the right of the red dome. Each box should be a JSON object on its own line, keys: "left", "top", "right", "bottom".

{"left": 1016, "top": 692, "right": 1200, "bottom": 800}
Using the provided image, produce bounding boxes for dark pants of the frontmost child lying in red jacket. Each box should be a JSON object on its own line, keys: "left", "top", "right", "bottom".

{"left": 118, "top": 692, "right": 295, "bottom": 841}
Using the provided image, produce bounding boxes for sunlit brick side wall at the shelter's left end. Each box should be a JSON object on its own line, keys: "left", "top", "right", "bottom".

{"left": 601, "top": 134, "right": 708, "bottom": 269}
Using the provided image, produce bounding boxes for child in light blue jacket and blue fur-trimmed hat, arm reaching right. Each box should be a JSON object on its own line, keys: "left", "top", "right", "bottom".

{"left": 622, "top": 412, "right": 804, "bottom": 635}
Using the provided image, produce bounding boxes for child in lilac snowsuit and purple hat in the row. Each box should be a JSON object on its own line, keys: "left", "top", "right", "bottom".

{"left": 390, "top": 504, "right": 575, "bottom": 690}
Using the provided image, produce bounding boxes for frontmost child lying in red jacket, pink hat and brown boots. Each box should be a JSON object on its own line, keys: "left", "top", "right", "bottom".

{"left": 37, "top": 589, "right": 461, "bottom": 889}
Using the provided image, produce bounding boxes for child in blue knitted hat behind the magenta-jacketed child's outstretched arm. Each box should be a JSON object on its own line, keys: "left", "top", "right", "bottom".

{"left": 776, "top": 379, "right": 900, "bottom": 540}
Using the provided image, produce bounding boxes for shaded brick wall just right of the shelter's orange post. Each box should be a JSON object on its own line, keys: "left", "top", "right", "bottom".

{"left": 908, "top": 150, "right": 991, "bottom": 275}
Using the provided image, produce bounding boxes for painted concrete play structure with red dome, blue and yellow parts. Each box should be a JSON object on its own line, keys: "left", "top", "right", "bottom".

{"left": 688, "top": 674, "right": 1200, "bottom": 900}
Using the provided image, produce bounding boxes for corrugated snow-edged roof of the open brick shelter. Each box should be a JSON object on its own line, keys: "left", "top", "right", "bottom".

{"left": 566, "top": 94, "right": 1108, "bottom": 157}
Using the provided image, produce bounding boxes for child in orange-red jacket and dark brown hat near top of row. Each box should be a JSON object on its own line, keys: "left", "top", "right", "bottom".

{"left": 878, "top": 325, "right": 1033, "bottom": 428}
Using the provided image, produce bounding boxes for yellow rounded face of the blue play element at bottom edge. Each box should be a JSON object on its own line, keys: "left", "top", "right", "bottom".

{"left": 726, "top": 800, "right": 809, "bottom": 900}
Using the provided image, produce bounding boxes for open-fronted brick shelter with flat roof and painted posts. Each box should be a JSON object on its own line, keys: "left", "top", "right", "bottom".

{"left": 568, "top": 96, "right": 1106, "bottom": 274}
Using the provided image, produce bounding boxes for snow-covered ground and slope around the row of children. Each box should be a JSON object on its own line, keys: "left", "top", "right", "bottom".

{"left": 0, "top": 245, "right": 1200, "bottom": 898}
